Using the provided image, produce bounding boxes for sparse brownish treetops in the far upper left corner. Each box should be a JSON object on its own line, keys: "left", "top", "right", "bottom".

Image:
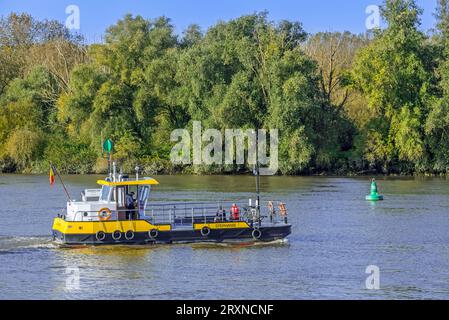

{"left": 0, "top": 13, "right": 85, "bottom": 94}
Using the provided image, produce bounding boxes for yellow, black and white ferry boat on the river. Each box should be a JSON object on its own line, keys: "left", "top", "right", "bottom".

{"left": 52, "top": 164, "right": 291, "bottom": 246}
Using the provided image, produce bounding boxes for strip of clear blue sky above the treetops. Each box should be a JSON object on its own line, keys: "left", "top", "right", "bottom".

{"left": 0, "top": 0, "right": 437, "bottom": 42}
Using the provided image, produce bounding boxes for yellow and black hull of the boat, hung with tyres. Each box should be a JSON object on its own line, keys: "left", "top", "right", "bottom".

{"left": 52, "top": 218, "right": 291, "bottom": 245}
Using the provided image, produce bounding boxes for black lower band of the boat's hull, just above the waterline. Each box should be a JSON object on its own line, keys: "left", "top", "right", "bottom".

{"left": 53, "top": 225, "right": 291, "bottom": 245}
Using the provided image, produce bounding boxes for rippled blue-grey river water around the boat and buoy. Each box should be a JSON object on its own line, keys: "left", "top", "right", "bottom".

{"left": 0, "top": 175, "right": 449, "bottom": 299}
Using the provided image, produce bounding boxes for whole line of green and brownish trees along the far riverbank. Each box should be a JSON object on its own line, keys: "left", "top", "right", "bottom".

{"left": 0, "top": 0, "right": 449, "bottom": 174}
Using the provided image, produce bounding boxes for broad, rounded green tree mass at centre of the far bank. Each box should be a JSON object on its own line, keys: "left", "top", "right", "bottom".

{"left": 178, "top": 12, "right": 352, "bottom": 173}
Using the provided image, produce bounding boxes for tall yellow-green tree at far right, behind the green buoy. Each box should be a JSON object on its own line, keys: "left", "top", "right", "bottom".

{"left": 352, "top": 0, "right": 431, "bottom": 171}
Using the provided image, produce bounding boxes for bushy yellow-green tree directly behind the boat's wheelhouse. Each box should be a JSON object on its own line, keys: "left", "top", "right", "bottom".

{"left": 58, "top": 15, "right": 188, "bottom": 164}
